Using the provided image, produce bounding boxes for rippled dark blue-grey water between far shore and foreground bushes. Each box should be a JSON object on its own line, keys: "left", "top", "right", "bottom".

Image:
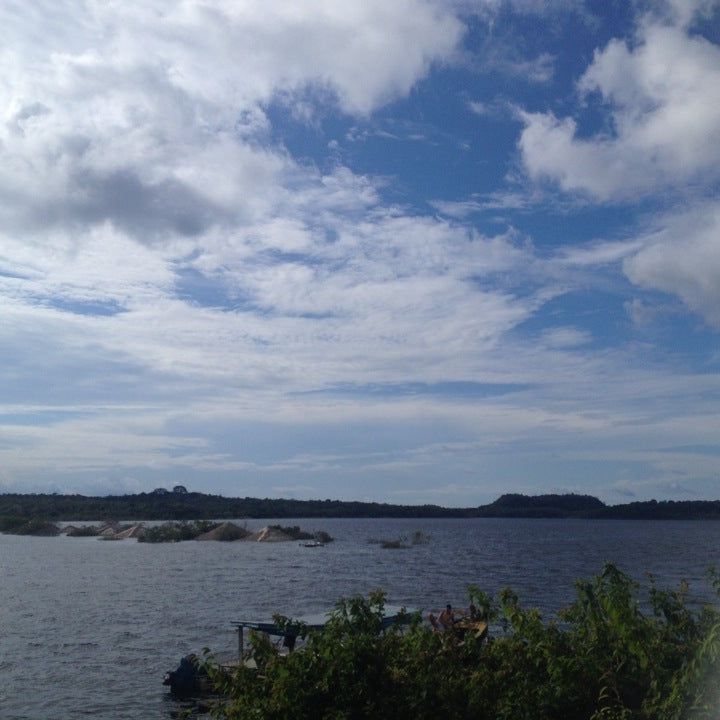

{"left": 0, "top": 520, "right": 720, "bottom": 720}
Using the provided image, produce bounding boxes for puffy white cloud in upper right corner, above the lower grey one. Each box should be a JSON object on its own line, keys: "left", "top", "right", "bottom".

{"left": 519, "top": 9, "right": 720, "bottom": 201}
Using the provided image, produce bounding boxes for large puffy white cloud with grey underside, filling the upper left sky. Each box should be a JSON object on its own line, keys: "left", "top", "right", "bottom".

{"left": 0, "top": 0, "right": 463, "bottom": 241}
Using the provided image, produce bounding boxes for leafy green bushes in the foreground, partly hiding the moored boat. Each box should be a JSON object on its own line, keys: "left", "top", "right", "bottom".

{"left": 205, "top": 565, "right": 720, "bottom": 720}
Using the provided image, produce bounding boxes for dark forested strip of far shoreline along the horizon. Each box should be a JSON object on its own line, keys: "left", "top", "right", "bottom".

{"left": 0, "top": 486, "right": 720, "bottom": 520}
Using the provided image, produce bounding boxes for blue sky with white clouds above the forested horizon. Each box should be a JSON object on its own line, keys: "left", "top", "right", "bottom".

{"left": 0, "top": 0, "right": 720, "bottom": 506}
